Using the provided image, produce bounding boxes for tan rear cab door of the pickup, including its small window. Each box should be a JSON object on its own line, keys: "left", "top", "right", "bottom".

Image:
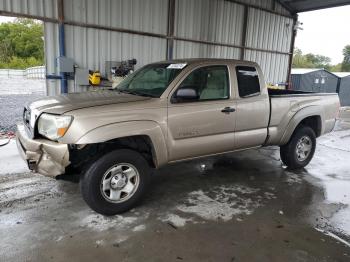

{"left": 233, "top": 63, "right": 270, "bottom": 149}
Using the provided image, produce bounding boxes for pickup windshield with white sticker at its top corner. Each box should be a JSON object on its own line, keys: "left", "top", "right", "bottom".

{"left": 117, "top": 63, "right": 186, "bottom": 97}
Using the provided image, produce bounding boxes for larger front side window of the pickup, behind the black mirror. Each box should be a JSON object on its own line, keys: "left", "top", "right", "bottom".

{"left": 172, "top": 66, "right": 230, "bottom": 103}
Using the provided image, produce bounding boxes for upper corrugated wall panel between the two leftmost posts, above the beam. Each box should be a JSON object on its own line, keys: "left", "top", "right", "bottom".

{"left": 64, "top": 0, "right": 168, "bottom": 34}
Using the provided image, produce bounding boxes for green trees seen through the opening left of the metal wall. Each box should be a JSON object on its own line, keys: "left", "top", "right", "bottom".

{"left": 0, "top": 18, "right": 44, "bottom": 69}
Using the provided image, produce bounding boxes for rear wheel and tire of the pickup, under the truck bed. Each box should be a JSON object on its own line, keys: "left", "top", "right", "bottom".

{"left": 280, "top": 126, "right": 316, "bottom": 169}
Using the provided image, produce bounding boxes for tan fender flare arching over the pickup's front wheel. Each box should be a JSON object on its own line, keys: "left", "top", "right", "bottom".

{"left": 74, "top": 121, "right": 168, "bottom": 167}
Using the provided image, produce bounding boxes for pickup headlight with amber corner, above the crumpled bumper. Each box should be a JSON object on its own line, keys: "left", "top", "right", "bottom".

{"left": 38, "top": 114, "right": 72, "bottom": 140}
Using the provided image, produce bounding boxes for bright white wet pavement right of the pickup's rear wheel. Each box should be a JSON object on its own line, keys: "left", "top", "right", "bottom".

{"left": 306, "top": 126, "right": 350, "bottom": 237}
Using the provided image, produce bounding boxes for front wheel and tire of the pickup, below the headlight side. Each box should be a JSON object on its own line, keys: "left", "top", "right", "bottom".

{"left": 80, "top": 149, "right": 151, "bottom": 216}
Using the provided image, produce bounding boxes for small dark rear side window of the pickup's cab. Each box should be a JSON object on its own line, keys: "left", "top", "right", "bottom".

{"left": 236, "top": 66, "right": 260, "bottom": 97}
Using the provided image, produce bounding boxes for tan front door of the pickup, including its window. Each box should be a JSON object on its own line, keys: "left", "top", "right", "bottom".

{"left": 168, "top": 64, "right": 236, "bottom": 161}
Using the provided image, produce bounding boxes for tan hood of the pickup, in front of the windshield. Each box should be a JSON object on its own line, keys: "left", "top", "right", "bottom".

{"left": 29, "top": 91, "right": 150, "bottom": 114}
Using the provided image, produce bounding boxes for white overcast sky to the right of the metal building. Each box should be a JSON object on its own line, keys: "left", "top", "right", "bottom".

{"left": 295, "top": 6, "right": 350, "bottom": 64}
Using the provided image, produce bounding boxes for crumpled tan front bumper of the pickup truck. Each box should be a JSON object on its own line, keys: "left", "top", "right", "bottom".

{"left": 16, "top": 125, "right": 70, "bottom": 177}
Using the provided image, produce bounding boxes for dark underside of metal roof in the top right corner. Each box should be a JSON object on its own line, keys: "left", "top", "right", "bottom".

{"left": 279, "top": 0, "right": 350, "bottom": 13}
